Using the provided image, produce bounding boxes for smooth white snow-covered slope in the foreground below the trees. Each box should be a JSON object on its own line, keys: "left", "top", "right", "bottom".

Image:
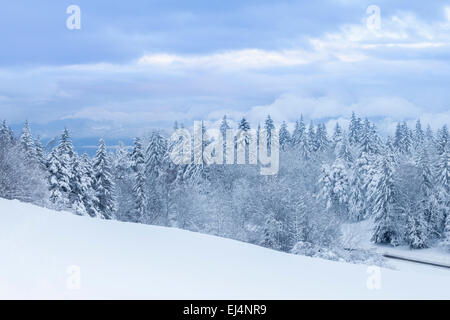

{"left": 0, "top": 199, "right": 450, "bottom": 299}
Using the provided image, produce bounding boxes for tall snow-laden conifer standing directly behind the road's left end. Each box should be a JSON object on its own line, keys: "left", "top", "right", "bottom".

{"left": 371, "top": 153, "right": 400, "bottom": 246}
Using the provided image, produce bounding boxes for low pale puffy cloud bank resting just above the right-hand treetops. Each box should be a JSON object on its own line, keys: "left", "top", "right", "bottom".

{"left": 210, "top": 94, "right": 442, "bottom": 134}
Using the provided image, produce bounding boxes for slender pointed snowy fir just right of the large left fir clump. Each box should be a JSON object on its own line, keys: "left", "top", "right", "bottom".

{"left": 93, "top": 139, "right": 116, "bottom": 219}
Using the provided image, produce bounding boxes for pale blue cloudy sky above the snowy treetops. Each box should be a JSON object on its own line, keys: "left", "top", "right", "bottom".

{"left": 0, "top": 0, "right": 450, "bottom": 138}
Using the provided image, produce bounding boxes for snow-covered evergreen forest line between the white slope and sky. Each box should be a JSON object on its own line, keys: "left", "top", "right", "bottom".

{"left": 0, "top": 113, "right": 450, "bottom": 255}
